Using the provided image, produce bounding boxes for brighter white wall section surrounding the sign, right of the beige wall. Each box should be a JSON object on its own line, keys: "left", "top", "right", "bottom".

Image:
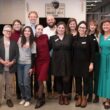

{"left": 26, "top": 0, "right": 86, "bottom": 22}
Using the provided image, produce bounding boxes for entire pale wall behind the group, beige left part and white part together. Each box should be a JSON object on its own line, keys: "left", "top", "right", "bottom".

{"left": 0, "top": 0, "right": 86, "bottom": 24}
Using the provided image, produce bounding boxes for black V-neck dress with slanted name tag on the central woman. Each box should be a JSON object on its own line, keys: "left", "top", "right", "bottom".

{"left": 49, "top": 35, "right": 73, "bottom": 76}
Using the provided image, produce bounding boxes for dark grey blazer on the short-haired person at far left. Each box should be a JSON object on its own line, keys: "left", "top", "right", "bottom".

{"left": 0, "top": 38, "right": 19, "bottom": 73}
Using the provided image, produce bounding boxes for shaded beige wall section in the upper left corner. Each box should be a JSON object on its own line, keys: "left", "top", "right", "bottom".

{"left": 0, "top": 0, "right": 25, "bottom": 24}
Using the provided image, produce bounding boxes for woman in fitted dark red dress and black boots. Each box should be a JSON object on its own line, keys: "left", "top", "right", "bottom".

{"left": 35, "top": 24, "right": 50, "bottom": 108}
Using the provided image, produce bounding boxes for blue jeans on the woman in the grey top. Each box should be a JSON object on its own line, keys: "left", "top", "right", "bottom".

{"left": 17, "top": 64, "right": 31, "bottom": 101}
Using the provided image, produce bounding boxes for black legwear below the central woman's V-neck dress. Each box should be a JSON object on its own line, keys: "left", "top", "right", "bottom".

{"left": 55, "top": 76, "right": 70, "bottom": 94}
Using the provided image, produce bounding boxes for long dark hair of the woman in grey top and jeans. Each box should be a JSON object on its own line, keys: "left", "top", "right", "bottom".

{"left": 21, "top": 26, "right": 34, "bottom": 47}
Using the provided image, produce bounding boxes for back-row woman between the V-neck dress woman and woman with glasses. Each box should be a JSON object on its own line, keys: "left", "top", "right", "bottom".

{"left": 67, "top": 18, "right": 77, "bottom": 100}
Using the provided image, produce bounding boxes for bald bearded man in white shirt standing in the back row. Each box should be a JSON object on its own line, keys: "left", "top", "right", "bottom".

{"left": 43, "top": 15, "right": 56, "bottom": 98}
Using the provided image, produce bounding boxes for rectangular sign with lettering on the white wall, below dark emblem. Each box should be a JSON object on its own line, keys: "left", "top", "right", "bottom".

{"left": 45, "top": 3, "right": 65, "bottom": 18}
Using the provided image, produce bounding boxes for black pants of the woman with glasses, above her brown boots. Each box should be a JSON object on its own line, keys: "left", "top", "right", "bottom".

{"left": 75, "top": 77, "right": 89, "bottom": 96}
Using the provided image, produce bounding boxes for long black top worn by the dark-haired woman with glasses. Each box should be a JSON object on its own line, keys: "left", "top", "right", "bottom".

{"left": 73, "top": 36, "right": 94, "bottom": 77}
